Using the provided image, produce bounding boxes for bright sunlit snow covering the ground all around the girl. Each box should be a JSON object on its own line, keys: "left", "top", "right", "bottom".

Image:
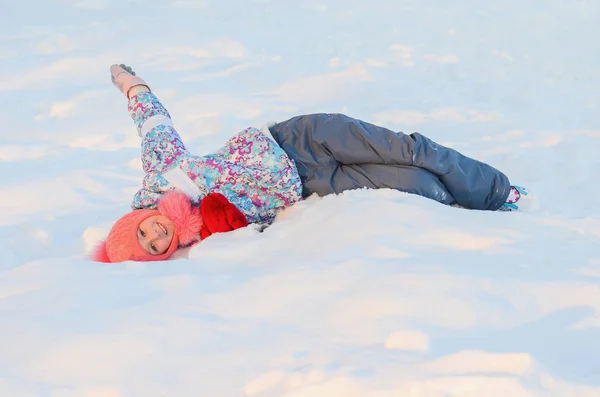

{"left": 0, "top": 0, "right": 600, "bottom": 397}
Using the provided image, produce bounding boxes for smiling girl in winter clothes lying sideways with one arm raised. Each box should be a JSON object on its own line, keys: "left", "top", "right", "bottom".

{"left": 92, "top": 65, "right": 527, "bottom": 262}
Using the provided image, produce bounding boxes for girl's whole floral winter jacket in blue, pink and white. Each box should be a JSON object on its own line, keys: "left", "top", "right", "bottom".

{"left": 129, "top": 92, "right": 302, "bottom": 224}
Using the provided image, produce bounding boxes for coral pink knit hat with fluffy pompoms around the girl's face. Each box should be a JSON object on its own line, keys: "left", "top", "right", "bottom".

{"left": 91, "top": 191, "right": 202, "bottom": 263}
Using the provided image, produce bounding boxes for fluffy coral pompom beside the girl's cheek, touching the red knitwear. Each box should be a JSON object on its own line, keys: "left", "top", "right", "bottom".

{"left": 158, "top": 190, "right": 202, "bottom": 246}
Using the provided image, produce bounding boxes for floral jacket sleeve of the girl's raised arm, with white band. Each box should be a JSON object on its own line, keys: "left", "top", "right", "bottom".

{"left": 129, "top": 92, "right": 187, "bottom": 176}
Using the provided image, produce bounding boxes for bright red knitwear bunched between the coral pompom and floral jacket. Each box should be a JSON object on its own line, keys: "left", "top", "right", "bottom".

{"left": 200, "top": 193, "right": 248, "bottom": 240}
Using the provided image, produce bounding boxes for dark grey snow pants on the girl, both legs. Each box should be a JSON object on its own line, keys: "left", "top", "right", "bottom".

{"left": 269, "top": 114, "right": 510, "bottom": 211}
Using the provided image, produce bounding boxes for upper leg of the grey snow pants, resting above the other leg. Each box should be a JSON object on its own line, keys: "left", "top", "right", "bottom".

{"left": 271, "top": 114, "right": 510, "bottom": 210}
